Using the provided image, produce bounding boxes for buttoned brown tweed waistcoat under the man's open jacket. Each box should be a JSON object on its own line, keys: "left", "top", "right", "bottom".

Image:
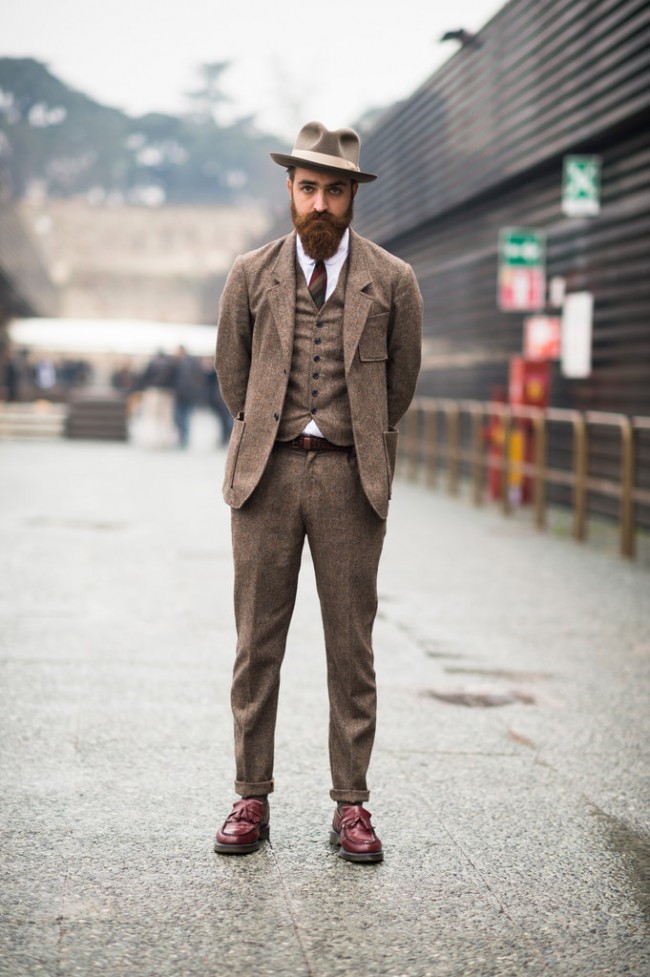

{"left": 278, "top": 261, "right": 354, "bottom": 444}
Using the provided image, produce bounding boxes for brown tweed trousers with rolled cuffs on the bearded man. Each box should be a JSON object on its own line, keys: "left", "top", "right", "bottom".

{"left": 231, "top": 447, "right": 386, "bottom": 801}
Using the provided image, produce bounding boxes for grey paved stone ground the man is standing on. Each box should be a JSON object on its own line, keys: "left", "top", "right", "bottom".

{"left": 0, "top": 426, "right": 650, "bottom": 977}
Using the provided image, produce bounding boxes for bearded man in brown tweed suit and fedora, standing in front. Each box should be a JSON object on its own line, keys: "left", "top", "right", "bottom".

{"left": 215, "top": 122, "right": 422, "bottom": 862}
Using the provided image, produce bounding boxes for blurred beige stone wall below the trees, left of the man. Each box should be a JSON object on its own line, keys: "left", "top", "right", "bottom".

{"left": 20, "top": 199, "right": 270, "bottom": 323}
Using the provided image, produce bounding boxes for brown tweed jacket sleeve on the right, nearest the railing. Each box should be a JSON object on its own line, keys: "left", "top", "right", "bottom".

{"left": 387, "top": 265, "right": 424, "bottom": 427}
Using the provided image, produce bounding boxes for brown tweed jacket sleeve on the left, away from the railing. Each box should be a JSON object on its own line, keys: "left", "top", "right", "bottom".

{"left": 214, "top": 256, "right": 253, "bottom": 417}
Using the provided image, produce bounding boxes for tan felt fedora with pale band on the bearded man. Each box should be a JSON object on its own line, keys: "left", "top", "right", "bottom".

{"left": 270, "top": 122, "right": 377, "bottom": 183}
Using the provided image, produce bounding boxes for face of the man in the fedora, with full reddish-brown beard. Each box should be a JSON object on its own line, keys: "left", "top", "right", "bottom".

{"left": 287, "top": 167, "right": 358, "bottom": 260}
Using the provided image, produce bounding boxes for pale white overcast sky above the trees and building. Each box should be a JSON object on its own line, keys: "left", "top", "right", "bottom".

{"left": 0, "top": 0, "right": 505, "bottom": 142}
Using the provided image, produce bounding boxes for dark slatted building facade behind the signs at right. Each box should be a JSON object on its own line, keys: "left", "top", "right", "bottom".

{"left": 355, "top": 0, "right": 650, "bottom": 415}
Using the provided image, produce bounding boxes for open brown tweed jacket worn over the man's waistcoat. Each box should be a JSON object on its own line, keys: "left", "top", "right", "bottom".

{"left": 215, "top": 231, "right": 422, "bottom": 519}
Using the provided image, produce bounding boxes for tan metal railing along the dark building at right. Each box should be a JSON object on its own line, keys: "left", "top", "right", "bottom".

{"left": 398, "top": 397, "right": 650, "bottom": 559}
